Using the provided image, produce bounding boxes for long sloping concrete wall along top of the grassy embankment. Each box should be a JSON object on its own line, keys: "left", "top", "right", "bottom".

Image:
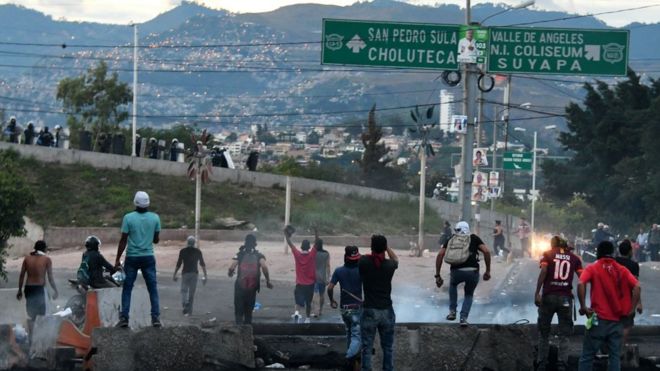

{"left": 0, "top": 142, "right": 518, "bottom": 250}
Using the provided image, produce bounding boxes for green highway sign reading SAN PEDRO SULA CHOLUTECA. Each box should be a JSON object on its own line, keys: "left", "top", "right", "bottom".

{"left": 321, "top": 19, "right": 461, "bottom": 70}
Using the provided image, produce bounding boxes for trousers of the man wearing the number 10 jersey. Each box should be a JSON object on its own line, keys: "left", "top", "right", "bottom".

{"left": 537, "top": 295, "right": 573, "bottom": 371}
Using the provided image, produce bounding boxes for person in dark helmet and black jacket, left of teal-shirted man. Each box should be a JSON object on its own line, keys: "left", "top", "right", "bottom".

{"left": 78, "top": 236, "right": 117, "bottom": 289}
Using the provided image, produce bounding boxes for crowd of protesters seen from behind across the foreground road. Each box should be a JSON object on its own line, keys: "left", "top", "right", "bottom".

{"left": 16, "top": 196, "right": 657, "bottom": 370}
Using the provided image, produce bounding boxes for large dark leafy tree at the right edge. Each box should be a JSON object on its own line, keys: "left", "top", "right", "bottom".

{"left": 542, "top": 70, "right": 660, "bottom": 227}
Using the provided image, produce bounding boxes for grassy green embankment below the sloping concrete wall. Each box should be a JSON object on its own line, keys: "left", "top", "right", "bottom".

{"left": 7, "top": 151, "right": 442, "bottom": 234}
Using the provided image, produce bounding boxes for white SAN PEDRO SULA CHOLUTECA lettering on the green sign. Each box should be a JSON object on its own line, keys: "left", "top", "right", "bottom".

{"left": 367, "top": 27, "right": 458, "bottom": 65}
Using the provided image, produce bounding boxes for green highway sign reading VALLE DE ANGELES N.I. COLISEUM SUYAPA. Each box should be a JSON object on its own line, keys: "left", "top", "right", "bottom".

{"left": 487, "top": 27, "right": 630, "bottom": 76}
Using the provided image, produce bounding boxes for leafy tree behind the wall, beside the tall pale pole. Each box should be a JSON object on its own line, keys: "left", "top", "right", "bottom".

{"left": 57, "top": 61, "right": 133, "bottom": 150}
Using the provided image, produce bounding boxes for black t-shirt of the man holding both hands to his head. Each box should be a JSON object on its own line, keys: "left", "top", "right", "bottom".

{"left": 359, "top": 255, "right": 399, "bottom": 309}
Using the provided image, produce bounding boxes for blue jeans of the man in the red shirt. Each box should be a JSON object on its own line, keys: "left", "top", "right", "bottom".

{"left": 578, "top": 318, "right": 623, "bottom": 371}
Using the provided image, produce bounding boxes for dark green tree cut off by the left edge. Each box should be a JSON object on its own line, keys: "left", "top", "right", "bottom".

{"left": 0, "top": 151, "right": 34, "bottom": 280}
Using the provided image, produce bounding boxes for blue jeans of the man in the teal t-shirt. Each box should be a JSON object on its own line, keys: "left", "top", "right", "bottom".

{"left": 119, "top": 255, "right": 160, "bottom": 319}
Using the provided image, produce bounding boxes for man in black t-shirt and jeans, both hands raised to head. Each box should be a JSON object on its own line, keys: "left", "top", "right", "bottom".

{"left": 358, "top": 234, "right": 399, "bottom": 371}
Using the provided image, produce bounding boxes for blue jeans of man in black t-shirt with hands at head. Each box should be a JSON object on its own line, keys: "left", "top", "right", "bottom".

{"left": 361, "top": 308, "right": 396, "bottom": 371}
